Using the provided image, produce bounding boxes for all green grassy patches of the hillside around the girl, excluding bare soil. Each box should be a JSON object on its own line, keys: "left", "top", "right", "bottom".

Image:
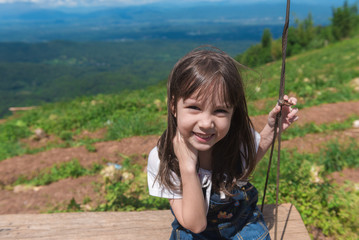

{"left": 0, "top": 35, "right": 359, "bottom": 239}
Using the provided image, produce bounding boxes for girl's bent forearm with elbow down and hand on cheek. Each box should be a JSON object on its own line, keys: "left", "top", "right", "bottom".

{"left": 170, "top": 132, "right": 207, "bottom": 233}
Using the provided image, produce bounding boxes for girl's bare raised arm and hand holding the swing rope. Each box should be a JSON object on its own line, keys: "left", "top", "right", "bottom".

{"left": 256, "top": 95, "right": 298, "bottom": 163}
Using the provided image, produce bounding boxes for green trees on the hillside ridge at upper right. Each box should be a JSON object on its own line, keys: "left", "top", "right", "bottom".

{"left": 235, "top": 1, "right": 359, "bottom": 67}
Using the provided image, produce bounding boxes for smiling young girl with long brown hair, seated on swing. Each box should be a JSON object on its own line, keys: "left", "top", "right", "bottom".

{"left": 147, "top": 48, "right": 298, "bottom": 239}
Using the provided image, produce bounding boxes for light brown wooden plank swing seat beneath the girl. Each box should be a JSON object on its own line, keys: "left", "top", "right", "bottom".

{"left": 0, "top": 204, "right": 310, "bottom": 240}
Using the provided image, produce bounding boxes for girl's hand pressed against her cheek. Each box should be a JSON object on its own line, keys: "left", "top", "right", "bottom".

{"left": 173, "top": 130, "right": 198, "bottom": 171}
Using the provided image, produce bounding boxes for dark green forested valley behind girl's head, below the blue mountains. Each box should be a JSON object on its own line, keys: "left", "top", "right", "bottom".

{"left": 0, "top": 40, "right": 253, "bottom": 117}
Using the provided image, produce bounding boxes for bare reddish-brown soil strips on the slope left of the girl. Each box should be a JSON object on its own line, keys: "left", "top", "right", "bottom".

{"left": 0, "top": 136, "right": 158, "bottom": 214}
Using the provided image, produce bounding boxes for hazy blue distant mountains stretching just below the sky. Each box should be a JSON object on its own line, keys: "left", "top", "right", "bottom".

{"left": 0, "top": 2, "right": 338, "bottom": 42}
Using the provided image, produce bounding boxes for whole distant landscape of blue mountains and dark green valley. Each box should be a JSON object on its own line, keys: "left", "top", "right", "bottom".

{"left": 0, "top": 2, "right": 356, "bottom": 117}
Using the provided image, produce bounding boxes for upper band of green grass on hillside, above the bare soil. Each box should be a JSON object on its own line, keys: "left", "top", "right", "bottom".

{"left": 0, "top": 38, "right": 359, "bottom": 162}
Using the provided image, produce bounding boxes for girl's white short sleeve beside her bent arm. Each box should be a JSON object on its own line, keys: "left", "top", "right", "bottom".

{"left": 147, "top": 147, "right": 182, "bottom": 199}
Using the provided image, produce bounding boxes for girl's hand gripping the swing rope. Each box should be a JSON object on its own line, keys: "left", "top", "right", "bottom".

{"left": 268, "top": 95, "right": 298, "bottom": 130}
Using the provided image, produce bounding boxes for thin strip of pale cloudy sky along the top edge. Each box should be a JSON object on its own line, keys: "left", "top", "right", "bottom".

{"left": 0, "top": 0, "right": 357, "bottom": 7}
